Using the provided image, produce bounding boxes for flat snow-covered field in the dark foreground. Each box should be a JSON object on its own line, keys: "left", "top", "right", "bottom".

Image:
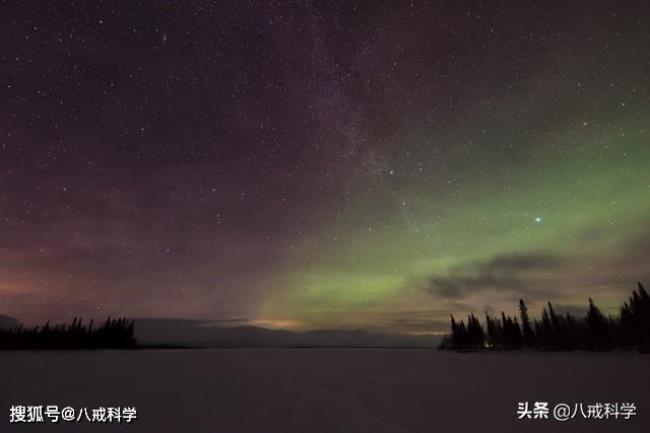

{"left": 0, "top": 349, "right": 650, "bottom": 433}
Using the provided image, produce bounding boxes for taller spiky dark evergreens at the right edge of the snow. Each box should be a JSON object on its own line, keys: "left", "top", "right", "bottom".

{"left": 440, "top": 283, "right": 650, "bottom": 352}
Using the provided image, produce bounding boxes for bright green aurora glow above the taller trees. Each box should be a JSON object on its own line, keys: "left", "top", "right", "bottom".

{"left": 261, "top": 113, "right": 650, "bottom": 332}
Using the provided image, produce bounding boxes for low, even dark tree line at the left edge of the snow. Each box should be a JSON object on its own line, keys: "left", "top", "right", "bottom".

{"left": 0, "top": 317, "right": 136, "bottom": 350}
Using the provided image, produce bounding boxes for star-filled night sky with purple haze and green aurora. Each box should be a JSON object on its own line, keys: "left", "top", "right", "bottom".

{"left": 0, "top": 1, "right": 650, "bottom": 333}
